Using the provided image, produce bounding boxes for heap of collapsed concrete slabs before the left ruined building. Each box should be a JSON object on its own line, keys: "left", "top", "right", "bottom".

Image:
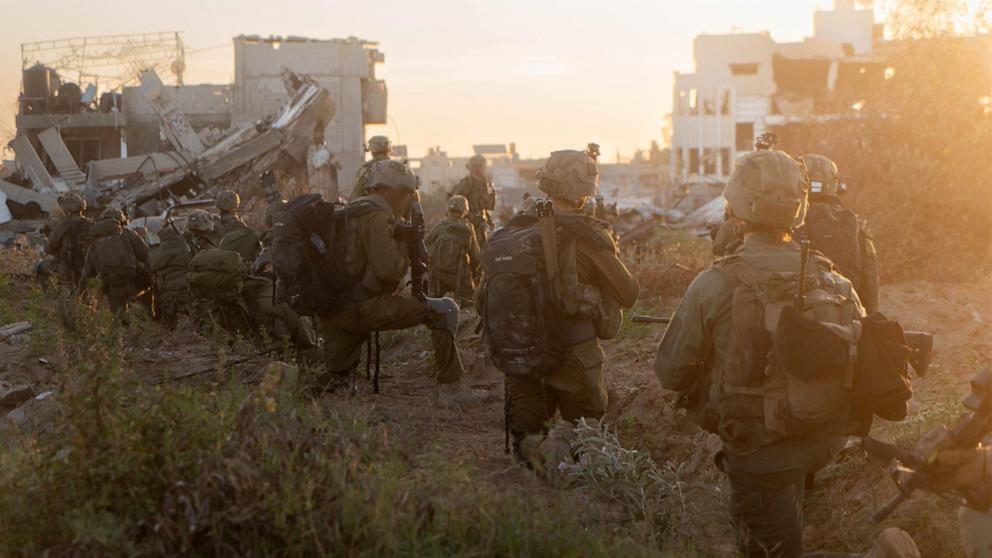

{"left": 0, "top": 66, "right": 335, "bottom": 242}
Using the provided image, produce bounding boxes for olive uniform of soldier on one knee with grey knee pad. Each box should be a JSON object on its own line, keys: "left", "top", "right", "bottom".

{"left": 320, "top": 194, "right": 463, "bottom": 390}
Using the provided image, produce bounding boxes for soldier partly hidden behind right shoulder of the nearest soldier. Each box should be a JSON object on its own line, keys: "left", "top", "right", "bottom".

{"left": 802, "top": 155, "right": 878, "bottom": 314}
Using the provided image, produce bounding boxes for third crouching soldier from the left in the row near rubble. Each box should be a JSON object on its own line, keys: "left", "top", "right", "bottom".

{"left": 148, "top": 223, "right": 193, "bottom": 329}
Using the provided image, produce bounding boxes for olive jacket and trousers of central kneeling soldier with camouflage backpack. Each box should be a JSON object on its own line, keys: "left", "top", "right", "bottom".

{"left": 506, "top": 211, "right": 640, "bottom": 458}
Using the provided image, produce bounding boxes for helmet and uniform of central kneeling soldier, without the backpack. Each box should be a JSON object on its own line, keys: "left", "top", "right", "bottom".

{"left": 496, "top": 151, "right": 640, "bottom": 463}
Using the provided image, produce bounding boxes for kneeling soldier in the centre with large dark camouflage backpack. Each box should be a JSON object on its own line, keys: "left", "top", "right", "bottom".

{"left": 478, "top": 150, "right": 639, "bottom": 466}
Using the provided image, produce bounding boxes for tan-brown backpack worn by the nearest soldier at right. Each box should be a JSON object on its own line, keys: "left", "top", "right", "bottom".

{"left": 715, "top": 250, "right": 861, "bottom": 452}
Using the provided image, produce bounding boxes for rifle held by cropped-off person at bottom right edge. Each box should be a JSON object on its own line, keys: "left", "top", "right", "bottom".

{"left": 862, "top": 368, "right": 992, "bottom": 523}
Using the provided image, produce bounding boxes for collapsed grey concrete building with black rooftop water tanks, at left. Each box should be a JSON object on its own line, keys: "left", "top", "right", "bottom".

{"left": 0, "top": 33, "right": 386, "bottom": 225}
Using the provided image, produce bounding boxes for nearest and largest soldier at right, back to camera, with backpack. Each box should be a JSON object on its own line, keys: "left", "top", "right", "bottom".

{"left": 655, "top": 150, "right": 864, "bottom": 557}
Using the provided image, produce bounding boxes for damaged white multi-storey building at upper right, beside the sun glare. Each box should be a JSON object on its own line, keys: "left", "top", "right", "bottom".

{"left": 671, "top": 0, "right": 885, "bottom": 184}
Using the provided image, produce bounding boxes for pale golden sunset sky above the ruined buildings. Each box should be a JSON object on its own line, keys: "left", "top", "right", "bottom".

{"left": 0, "top": 0, "right": 877, "bottom": 159}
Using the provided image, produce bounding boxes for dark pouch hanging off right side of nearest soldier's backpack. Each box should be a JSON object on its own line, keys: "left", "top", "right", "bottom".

{"left": 854, "top": 312, "right": 913, "bottom": 421}
